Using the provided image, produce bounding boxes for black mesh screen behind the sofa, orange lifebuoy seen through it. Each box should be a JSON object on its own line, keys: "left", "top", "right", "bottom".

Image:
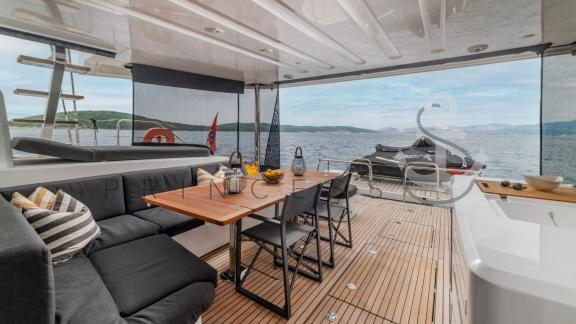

{"left": 132, "top": 65, "right": 280, "bottom": 167}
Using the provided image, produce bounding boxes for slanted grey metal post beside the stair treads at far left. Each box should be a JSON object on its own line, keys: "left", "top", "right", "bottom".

{"left": 41, "top": 46, "right": 66, "bottom": 140}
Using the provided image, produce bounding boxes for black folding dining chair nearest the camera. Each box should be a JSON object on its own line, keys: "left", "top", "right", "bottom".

{"left": 236, "top": 185, "right": 322, "bottom": 318}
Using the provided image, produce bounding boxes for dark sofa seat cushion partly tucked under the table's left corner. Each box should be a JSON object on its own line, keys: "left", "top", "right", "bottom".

{"left": 133, "top": 207, "right": 204, "bottom": 236}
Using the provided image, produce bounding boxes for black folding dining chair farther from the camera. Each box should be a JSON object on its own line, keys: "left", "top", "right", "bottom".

{"left": 302, "top": 168, "right": 352, "bottom": 268}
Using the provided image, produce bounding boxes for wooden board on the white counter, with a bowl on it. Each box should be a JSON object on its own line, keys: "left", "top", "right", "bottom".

{"left": 476, "top": 180, "right": 576, "bottom": 203}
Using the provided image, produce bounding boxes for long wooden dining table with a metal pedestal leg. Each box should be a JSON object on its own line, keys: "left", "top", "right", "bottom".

{"left": 143, "top": 169, "right": 338, "bottom": 281}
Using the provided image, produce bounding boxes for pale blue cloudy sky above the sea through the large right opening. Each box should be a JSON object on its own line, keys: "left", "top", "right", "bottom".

{"left": 280, "top": 59, "right": 540, "bottom": 129}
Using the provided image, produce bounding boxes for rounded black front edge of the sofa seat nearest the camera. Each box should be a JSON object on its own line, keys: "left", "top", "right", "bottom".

{"left": 126, "top": 282, "right": 215, "bottom": 324}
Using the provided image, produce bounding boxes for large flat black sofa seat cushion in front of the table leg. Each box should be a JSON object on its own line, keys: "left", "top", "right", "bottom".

{"left": 90, "top": 234, "right": 217, "bottom": 316}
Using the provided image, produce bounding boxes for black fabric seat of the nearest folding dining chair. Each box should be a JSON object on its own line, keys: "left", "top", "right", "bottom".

{"left": 242, "top": 221, "right": 314, "bottom": 246}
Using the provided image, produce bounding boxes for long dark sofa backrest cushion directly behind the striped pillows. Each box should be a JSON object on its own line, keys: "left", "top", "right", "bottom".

{"left": 0, "top": 174, "right": 126, "bottom": 221}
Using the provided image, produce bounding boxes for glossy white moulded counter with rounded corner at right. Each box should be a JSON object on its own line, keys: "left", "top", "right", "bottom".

{"left": 453, "top": 176, "right": 576, "bottom": 307}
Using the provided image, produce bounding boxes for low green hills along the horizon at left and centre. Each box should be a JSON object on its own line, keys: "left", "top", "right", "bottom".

{"left": 9, "top": 111, "right": 377, "bottom": 133}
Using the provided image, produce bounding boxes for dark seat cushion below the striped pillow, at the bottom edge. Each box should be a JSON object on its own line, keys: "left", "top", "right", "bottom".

{"left": 54, "top": 254, "right": 122, "bottom": 324}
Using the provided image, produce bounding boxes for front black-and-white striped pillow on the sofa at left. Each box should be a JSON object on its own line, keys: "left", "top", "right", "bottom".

{"left": 23, "top": 190, "right": 101, "bottom": 264}
